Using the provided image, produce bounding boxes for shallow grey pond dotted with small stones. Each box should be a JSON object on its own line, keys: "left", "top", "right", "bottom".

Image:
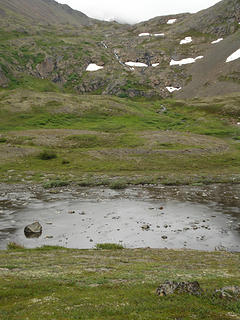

{"left": 0, "top": 185, "right": 240, "bottom": 251}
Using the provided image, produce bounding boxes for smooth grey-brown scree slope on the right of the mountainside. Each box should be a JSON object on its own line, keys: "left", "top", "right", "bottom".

{"left": 177, "top": 30, "right": 240, "bottom": 98}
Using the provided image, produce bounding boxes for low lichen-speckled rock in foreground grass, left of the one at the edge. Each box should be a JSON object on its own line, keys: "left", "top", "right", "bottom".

{"left": 156, "top": 281, "right": 202, "bottom": 297}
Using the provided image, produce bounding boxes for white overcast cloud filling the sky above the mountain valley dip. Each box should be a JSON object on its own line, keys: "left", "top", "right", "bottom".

{"left": 58, "top": 0, "right": 219, "bottom": 23}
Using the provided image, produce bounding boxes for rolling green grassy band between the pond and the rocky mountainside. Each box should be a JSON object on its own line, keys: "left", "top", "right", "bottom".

{"left": 0, "top": 89, "right": 240, "bottom": 188}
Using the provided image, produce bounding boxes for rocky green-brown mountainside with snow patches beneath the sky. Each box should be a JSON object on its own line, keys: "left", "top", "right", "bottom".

{"left": 0, "top": 0, "right": 240, "bottom": 98}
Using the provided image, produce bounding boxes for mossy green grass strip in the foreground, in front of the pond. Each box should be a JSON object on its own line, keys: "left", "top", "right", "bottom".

{"left": 0, "top": 247, "right": 240, "bottom": 320}
